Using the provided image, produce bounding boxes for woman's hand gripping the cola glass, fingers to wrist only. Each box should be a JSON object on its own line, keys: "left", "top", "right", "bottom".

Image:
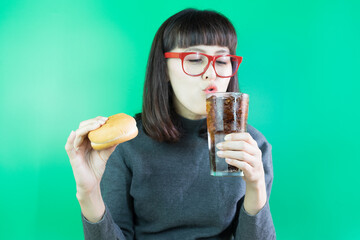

{"left": 216, "top": 132, "right": 265, "bottom": 189}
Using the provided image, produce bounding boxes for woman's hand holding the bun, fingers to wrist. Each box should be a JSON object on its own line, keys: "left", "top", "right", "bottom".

{"left": 65, "top": 116, "right": 116, "bottom": 197}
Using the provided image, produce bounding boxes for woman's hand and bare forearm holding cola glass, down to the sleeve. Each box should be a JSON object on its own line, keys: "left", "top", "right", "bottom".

{"left": 216, "top": 132, "right": 267, "bottom": 215}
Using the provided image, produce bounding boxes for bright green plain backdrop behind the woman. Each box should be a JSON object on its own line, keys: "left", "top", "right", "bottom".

{"left": 0, "top": 0, "right": 360, "bottom": 240}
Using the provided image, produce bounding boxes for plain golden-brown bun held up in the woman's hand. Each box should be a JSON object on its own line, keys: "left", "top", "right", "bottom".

{"left": 88, "top": 113, "right": 138, "bottom": 150}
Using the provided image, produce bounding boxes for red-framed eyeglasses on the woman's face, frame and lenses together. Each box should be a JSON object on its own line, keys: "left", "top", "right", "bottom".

{"left": 164, "top": 52, "right": 242, "bottom": 78}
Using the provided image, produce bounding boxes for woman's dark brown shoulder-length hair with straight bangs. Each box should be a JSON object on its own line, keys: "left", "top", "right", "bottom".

{"left": 136, "top": 8, "right": 240, "bottom": 142}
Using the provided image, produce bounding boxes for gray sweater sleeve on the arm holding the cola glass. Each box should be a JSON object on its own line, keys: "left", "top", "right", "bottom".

{"left": 235, "top": 130, "right": 276, "bottom": 240}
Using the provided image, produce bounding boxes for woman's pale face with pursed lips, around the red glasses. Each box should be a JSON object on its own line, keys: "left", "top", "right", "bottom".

{"left": 167, "top": 45, "right": 230, "bottom": 119}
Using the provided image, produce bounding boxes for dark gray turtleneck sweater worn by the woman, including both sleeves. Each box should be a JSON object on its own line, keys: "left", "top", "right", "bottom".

{"left": 81, "top": 113, "right": 276, "bottom": 240}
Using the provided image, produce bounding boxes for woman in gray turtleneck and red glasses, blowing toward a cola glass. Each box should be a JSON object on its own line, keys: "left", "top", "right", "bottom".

{"left": 65, "top": 9, "right": 276, "bottom": 240}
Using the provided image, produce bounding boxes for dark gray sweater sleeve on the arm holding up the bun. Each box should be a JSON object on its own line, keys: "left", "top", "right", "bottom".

{"left": 81, "top": 146, "right": 134, "bottom": 240}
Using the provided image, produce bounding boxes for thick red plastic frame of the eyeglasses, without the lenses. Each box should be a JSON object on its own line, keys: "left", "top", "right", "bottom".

{"left": 164, "top": 52, "right": 243, "bottom": 78}
